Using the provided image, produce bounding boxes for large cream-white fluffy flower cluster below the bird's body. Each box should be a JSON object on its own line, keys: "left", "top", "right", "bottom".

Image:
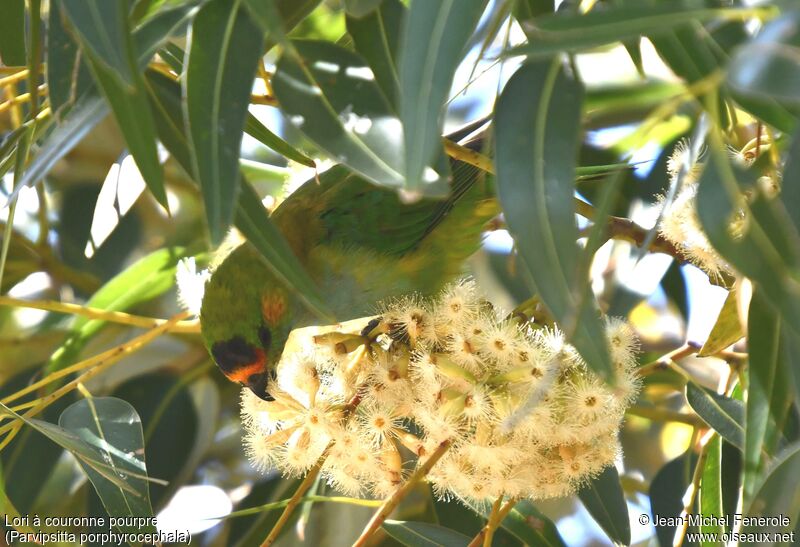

{"left": 242, "top": 282, "right": 638, "bottom": 506}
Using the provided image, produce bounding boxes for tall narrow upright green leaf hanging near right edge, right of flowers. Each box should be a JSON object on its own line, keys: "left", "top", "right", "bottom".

{"left": 743, "top": 292, "right": 792, "bottom": 504}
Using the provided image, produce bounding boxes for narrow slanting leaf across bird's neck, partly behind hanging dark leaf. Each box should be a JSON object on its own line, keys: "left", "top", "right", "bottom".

{"left": 147, "top": 72, "right": 331, "bottom": 318}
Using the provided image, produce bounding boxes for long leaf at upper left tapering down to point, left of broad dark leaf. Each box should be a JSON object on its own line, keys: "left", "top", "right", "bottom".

{"left": 62, "top": 0, "right": 168, "bottom": 209}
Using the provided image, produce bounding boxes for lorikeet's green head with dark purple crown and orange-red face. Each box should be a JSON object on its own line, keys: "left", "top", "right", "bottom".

{"left": 200, "top": 244, "right": 296, "bottom": 400}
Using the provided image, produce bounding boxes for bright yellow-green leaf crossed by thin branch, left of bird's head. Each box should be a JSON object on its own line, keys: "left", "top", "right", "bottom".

{"left": 47, "top": 248, "right": 185, "bottom": 372}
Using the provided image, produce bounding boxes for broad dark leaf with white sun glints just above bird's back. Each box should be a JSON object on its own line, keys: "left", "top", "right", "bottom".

{"left": 272, "top": 40, "right": 440, "bottom": 193}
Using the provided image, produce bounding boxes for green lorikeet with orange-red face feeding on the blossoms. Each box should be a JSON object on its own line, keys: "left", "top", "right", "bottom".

{"left": 200, "top": 148, "right": 497, "bottom": 399}
